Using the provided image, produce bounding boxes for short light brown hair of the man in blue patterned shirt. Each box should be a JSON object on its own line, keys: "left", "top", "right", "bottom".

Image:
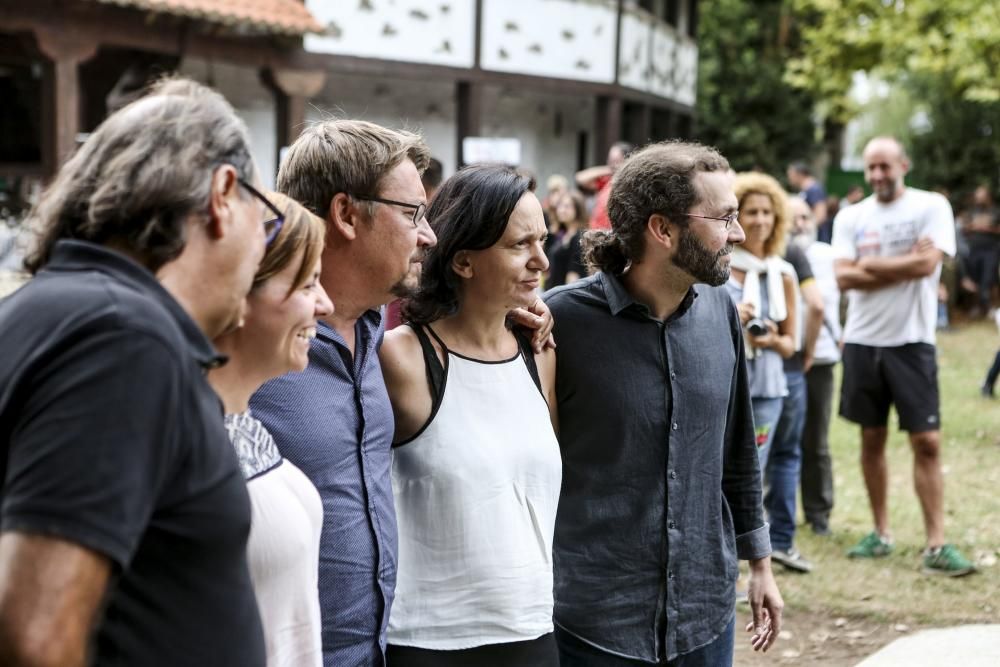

{"left": 277, "top": 120, "right": 431, "bottom": 220}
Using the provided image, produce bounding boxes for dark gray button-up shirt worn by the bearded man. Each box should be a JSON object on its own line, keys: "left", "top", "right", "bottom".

{"left": 545, "top": 273, "right": 771, "bottom": 662}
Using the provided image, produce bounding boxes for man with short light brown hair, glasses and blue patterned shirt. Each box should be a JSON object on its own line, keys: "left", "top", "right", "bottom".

{"left": 250, "top": 120, "right": 551, "bottom": 667}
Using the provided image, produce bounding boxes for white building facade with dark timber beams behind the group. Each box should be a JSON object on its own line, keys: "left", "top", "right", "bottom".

{"left": 303, "top": 0, "right": 698, "bottom": 179}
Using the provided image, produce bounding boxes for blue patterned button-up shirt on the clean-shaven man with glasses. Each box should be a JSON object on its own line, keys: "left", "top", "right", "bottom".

{"left": 250, "top": 311, "right": 397, "bottom": 667}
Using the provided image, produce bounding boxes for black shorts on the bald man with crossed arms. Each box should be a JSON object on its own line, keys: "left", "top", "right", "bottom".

{"left": 840, "top": 343, "right": 941, "bottom": 433}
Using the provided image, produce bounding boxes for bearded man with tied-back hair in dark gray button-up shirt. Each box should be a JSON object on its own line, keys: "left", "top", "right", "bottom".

{"left": 546, "top": 142, "right": 783, "bottom": 667}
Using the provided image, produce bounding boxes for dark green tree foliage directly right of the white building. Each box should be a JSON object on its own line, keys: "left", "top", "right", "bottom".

{"left": 697, "top": 0, "right": 819, "bottom": 174}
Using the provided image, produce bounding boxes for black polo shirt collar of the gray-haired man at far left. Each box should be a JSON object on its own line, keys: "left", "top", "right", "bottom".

{"left": 44, "top": 239, "right": 227, "bottom": 369}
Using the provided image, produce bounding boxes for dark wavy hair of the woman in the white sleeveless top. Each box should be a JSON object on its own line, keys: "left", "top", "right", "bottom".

{"left": 403, "top": 164, "right": 534, "bottom": 324}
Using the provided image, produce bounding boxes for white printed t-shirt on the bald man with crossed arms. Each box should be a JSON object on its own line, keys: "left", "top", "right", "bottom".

{"left": 832, "top": 187, "right": 955, "bottom": 347}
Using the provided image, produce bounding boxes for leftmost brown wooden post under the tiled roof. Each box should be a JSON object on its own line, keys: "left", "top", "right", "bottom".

{"left": 35, "top": 25, "right": 97, "bottom": 177}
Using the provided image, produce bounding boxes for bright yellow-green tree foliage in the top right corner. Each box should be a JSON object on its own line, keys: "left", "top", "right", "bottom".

{"left": 786, "top": 0, "right": 1000, "bottom": 120}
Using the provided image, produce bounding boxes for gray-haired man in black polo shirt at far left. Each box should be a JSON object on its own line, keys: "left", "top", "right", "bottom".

{"left": 0, "top": 80, "right": 270, "bottom": 667}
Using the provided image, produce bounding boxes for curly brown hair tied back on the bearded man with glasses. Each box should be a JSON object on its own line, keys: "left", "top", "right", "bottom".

{"left": 582, "top": 141, "right": 729, "bottom": 275}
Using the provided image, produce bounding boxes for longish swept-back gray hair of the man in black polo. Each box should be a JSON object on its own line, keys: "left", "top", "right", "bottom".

{"left": 25, "top": 78, "right": 256, "bottom": 273}
